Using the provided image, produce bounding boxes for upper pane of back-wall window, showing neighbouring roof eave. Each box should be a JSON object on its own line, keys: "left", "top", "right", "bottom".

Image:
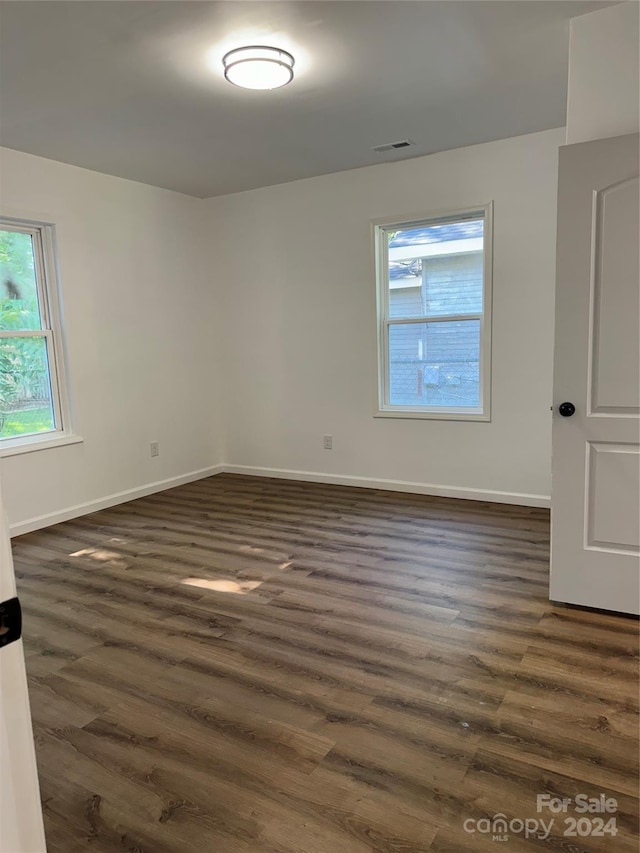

{"left": 388, "top": 219, "right": 484, "bottom": 317}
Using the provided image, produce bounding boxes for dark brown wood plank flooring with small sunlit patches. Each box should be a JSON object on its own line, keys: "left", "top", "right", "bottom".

{"left": 14, "top": 475, "right": 638, "bottom": 853}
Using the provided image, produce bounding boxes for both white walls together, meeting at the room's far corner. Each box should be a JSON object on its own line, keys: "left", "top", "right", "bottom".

{"left": 0, "top": 130, "right": 563, "bottom": 532}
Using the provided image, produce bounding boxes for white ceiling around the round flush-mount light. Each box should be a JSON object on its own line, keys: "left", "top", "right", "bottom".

{"left": 0, "top": 0, "right": 609, "bottom": 197}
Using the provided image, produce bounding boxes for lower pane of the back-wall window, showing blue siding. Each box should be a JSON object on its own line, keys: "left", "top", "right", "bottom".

{"left": 389, "top": 320, "right": 480, "bottom": 408}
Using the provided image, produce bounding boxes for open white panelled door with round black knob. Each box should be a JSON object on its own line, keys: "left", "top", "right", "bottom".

{"left": 550, "top": 134, "right": 640, "bottom": 614}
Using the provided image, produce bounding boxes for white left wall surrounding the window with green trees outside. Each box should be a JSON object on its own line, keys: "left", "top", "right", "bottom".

{"left": 0, "top": 149, "right": 222, "bottom": 532}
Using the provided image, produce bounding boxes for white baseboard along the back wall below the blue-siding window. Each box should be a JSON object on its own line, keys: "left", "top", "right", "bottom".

{"left": 222, "top": 465, "right": 551, "bottom": 507}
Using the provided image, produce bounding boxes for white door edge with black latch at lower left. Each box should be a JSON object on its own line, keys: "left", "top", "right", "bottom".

{"left": 0, "top": 480, "right": 46, "bottom": 853}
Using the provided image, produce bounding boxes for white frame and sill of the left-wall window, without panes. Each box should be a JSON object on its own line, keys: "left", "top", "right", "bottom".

{"left": 0, "top": 216, "right": 75, "bottom": 458}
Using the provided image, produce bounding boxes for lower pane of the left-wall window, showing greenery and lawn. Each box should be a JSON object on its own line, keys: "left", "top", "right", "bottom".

{"left": 0, "top": 337, "right": 55, "bottom": 438}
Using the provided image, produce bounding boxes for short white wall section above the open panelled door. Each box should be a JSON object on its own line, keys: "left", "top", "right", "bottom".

{"left": 567, "top": 2, "right": 640, "bottom": 144}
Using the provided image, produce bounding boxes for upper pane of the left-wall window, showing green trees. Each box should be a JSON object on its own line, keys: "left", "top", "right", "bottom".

{"left": 0, "top": 230, "right": 41, "bottom": 331}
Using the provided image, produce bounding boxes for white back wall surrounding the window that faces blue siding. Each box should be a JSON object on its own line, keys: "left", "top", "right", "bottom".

{"left": 205, "top": 129, "right": 564, "bottom": 503}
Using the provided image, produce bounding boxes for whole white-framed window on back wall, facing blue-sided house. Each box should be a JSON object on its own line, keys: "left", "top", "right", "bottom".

{"left": 374, "top": 204, "right": 492, "bottom": 420}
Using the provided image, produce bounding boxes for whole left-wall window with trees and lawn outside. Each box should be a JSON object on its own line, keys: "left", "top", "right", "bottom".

{"left": 0, "top": 220, "right": 68, "bottom": 451}
